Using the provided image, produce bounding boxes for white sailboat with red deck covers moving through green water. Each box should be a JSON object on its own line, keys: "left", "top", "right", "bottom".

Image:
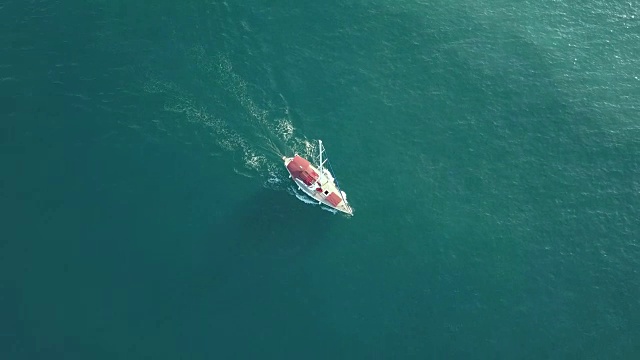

{"left": 282, "top": 140, "right": 353, "bottom": 215}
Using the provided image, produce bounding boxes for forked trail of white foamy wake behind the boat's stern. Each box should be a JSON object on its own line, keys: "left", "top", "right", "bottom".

{"left": 143, "top": 52, "right": 315, "bottom": 188}
